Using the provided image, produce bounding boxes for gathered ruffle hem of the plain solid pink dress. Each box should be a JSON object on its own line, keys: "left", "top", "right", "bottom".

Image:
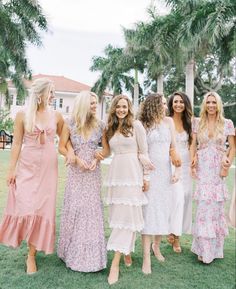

{"left": 0, "top": 215, "right": 55, "bottom": 254}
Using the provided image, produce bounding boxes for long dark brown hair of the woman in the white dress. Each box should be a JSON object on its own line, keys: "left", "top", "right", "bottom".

{"left": 168, "top": 91, "right": 193, "bottom": 145}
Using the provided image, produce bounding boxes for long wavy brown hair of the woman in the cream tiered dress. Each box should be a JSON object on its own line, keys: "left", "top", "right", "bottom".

{"left": 106, "top": 94, "right": 134, "bottom": 141}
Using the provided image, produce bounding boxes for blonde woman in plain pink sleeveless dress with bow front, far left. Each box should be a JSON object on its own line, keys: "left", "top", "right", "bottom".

{"left": 0, "top": 78, "right": 63, "bottom": 274}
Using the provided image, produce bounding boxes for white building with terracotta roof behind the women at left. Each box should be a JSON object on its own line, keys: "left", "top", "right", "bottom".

{"left": 0, "top": 74, "right": 112, "bottom": 120}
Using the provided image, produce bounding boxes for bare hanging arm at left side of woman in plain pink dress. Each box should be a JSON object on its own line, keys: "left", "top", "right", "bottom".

{"left": 7, "top": 112, "right": 24, "bottom": 185}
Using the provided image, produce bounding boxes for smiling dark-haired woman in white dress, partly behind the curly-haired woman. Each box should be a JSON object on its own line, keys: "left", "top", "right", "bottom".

{"left": 168, "top": 92, "right": 193, "bottom": 253}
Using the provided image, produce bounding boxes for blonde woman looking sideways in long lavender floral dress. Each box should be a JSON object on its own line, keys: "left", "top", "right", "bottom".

{"left": 58, "top": 91, "right": 109, "bottom": 272}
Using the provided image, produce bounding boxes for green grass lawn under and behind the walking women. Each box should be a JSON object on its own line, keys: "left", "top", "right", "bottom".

{"left": 0, "top": 151, "right": 236, "bottom": 289}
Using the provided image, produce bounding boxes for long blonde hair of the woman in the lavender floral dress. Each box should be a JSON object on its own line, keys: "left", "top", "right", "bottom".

{"left": 71, "top": 91, "right": 98, "bottom": 137}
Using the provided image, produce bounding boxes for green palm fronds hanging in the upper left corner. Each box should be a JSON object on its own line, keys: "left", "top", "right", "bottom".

{"left": 0, "top": 0, "right": 47, "bottom": 102}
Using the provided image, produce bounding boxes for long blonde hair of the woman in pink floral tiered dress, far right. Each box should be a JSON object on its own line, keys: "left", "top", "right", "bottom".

{"left": 198, "top": 91, "right": 225, "bottom": 140}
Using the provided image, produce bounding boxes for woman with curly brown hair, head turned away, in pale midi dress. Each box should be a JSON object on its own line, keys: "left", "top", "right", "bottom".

{"left": 140, "top": 93, "right": 179, "bottom": 274}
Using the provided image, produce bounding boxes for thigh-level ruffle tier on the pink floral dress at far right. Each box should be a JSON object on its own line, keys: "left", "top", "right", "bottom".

{"left": 193, "top": 183, "right": 228, "bottom": 202}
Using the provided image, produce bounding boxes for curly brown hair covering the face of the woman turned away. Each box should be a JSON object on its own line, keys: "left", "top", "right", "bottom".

{"left": 139, "top": 93, "right": 165, "bottom": 130}
